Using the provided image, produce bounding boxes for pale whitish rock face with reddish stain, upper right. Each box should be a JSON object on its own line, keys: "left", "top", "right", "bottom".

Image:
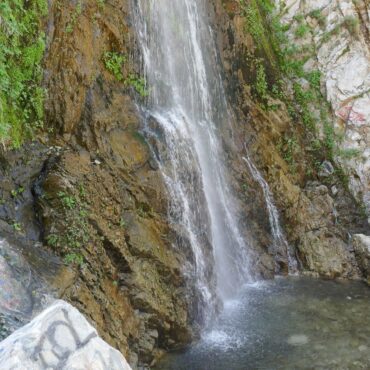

{"left": 281, "top": 0, "right": 370, "bottom": 223}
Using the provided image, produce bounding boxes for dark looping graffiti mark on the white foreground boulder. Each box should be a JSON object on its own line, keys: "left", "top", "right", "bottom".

{"left": 32, "top": 309, "right": 97, "bottom": 370}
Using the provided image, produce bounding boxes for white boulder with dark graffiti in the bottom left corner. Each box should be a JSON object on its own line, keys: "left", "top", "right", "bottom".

{"left": 0, "top": 300, "right": 131, "bottom": 370}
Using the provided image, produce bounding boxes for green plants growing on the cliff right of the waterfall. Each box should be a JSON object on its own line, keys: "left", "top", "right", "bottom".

{"left": 239, "top": 0, "right": 358, "bottom": 181}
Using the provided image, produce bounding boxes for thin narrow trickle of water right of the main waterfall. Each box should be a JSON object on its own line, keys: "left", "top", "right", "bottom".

{"left": 243, "top": 152, "right": 297, "bottom": 273}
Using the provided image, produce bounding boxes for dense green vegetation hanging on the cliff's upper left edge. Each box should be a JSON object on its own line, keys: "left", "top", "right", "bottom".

{"left": 0, "top": 0, "right": 48, "bottom": 147}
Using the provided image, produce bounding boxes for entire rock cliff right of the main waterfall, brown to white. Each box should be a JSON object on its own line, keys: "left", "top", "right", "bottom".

{"left": 212, "top": 0, "right": 369, "bottom": 278}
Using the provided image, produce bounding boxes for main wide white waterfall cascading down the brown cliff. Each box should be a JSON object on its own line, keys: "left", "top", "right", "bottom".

{"left": 133, "top": 0, "right": 249, "bottom": 316}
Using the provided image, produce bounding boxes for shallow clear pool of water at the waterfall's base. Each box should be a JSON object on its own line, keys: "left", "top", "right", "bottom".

{"left": 157, "top": 277, "right": 370, "bottom": 370}
